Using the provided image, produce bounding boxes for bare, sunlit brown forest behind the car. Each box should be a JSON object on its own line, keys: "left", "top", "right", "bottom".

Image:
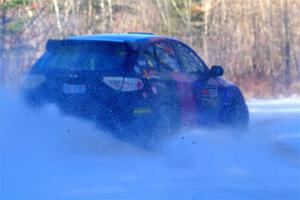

{"left": 0, "top": 0, "right": 300, "bottom": 97}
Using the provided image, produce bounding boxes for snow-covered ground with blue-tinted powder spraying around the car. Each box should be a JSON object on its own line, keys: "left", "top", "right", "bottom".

{"left": 0, "top": 91, "right": 300, "bottom": 200}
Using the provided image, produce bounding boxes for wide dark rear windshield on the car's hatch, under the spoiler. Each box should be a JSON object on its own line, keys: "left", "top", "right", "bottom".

{"left": 37, "top": 42, "right": 128, "bottom": 71}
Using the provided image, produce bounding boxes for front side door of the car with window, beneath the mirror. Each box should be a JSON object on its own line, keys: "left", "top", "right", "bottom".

{"left": 173, "top": 42, "right": 218, "bottom": 125}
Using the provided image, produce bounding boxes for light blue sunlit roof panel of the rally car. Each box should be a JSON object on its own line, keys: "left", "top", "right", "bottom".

{"left": 66, "top": 33, "right": 171, "bottom": 43}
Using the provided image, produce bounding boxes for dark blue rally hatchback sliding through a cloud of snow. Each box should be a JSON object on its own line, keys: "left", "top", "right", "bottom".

{"left": 23, "top": 33, "right": 249, "bottom": 134}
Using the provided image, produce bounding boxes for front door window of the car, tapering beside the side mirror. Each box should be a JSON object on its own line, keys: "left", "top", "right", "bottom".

{"left": 174, "top": 42, "right": 207, "bottom": 73}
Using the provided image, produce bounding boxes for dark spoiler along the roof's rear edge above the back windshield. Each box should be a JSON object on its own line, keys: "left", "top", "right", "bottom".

{"left": 46, "top": 39, "right": 139, "bottom": 51}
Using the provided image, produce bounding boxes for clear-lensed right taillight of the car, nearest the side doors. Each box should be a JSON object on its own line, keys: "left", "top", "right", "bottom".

{"left": 103, "top": 76, "right": 144, "bottom": 92}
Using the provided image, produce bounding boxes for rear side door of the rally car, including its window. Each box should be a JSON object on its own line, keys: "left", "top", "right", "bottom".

{"left": 139, "top": 41, "right": 181, "bottom": 125}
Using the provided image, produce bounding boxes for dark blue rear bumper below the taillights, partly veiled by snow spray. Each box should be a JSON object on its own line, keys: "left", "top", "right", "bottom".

{"left": 22, "top": 90, "right": 153, "bottom": 123}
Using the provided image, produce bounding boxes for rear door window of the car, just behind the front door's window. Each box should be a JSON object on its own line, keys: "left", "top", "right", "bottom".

{"left": 155, "top": 42, "right": 180, "bottom": 72}
